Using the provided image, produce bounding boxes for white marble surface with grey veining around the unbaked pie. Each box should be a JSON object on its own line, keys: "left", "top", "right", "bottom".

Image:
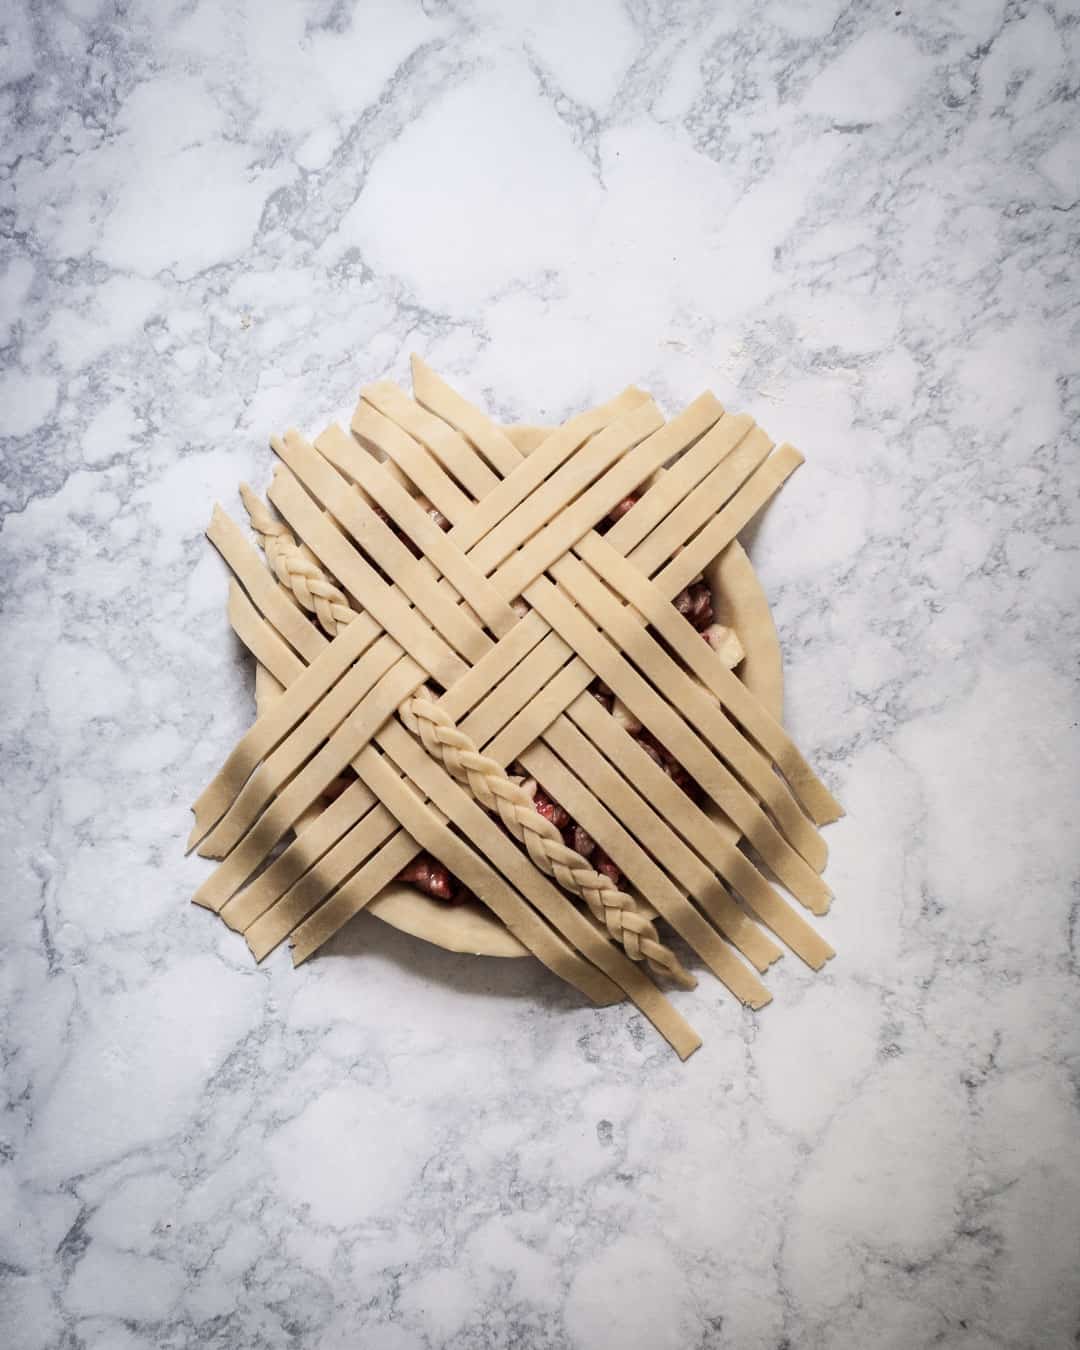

{"left": 0, "top": 0, "right": 1080, "bottom": 1350}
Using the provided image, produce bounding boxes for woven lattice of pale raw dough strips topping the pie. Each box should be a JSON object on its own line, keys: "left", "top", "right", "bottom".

{"left": 190, "top": 360, "right": 840, "bottom": 1056}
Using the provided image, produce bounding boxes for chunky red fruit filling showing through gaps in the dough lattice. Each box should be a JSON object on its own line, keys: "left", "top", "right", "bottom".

{"left": 388, "top": 493, "right": 726, "bottom": 905}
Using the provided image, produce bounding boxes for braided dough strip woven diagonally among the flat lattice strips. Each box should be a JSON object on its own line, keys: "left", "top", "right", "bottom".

{"left": 240, "top": 483, "right": 697, "bottom": 988}
